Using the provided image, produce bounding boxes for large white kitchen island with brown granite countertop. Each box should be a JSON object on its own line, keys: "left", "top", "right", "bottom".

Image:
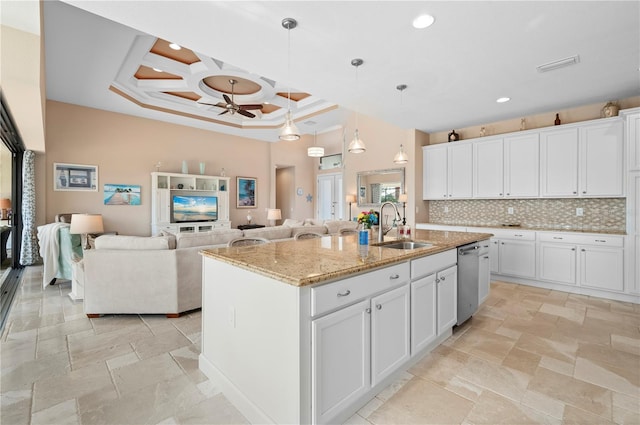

{"left": 200, "top": 230, "right": 491, "bottom": 423}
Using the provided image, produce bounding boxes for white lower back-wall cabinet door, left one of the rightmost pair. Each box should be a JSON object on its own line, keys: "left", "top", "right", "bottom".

{"left": 538, "top": 243, "right": 577, "bottom": 285}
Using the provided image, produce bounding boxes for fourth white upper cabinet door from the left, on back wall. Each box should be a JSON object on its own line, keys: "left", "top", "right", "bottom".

{"left": 504, "top": 134, "right": 540, "bottom": 198}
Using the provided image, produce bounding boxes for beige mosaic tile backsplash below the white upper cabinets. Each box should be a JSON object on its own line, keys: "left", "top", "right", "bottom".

{"left": 428, "top": 198, "right": 626, "bottom": 232}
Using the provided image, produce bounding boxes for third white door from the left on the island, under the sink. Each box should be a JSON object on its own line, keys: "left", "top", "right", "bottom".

{"left": 411, "top": 273, "right": 437, "bottom": 355}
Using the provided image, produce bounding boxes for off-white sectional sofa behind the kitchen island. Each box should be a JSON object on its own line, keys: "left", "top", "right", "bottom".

{"left": 82, "top": 220, "right": 356, "bottom": 317}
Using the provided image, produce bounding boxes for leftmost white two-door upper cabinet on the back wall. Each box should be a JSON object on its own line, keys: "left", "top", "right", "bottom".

{"left": 422, "top": 143, "right": 473, "bottom": 200}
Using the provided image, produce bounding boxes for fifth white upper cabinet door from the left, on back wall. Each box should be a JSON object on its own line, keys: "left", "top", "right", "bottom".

{"left": 540, "top": 127, "right": 578, "bottom": 197}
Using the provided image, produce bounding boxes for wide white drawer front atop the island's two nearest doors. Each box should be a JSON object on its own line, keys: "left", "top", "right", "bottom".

{"left": 311, "top": 262, "right": 409, "bottom": 316}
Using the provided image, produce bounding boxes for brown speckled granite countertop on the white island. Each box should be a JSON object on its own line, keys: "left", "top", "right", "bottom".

{"left": 201, "top": 230, "right": 492, "bottom": 286}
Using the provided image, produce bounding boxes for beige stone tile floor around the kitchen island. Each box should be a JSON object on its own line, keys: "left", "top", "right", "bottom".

{"left": 0, "top": 267, "right": 640, "bottom": 425}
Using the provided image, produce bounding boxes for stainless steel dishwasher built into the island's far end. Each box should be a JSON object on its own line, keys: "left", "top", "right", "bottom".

{"left": 456, "top": 242, "right": 480, "bottom": 325}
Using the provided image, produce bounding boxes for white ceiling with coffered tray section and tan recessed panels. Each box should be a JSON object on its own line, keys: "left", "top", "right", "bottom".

{"left": 43, "top": 0, "right": 640, "bottom": 141}
